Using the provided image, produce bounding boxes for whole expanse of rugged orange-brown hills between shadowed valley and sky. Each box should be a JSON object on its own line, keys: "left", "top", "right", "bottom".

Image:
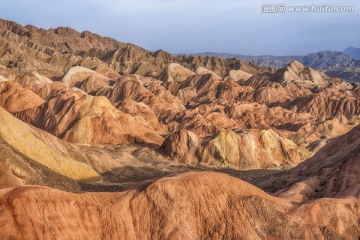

{"left": 0, "top": 20, "right": 360, "bottom": 169}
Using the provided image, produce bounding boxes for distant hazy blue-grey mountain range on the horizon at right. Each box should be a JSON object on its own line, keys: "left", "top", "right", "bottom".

{"left": 186, "top": 47, "right": 360, "bottom": 82}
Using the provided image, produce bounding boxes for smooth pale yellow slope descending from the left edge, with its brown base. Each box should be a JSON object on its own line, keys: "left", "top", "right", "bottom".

{"left": 0, "top": 108, "right": 101, "bottom": 189}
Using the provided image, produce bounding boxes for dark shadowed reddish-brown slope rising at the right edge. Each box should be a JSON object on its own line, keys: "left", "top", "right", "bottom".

{"left": 260, "top": 126, "right": 360, "bottom": 201}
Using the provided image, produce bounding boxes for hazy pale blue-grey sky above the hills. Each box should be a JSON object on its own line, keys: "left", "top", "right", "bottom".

{"left": 0, "top": 0, "right": 360, "bottom": 55}
